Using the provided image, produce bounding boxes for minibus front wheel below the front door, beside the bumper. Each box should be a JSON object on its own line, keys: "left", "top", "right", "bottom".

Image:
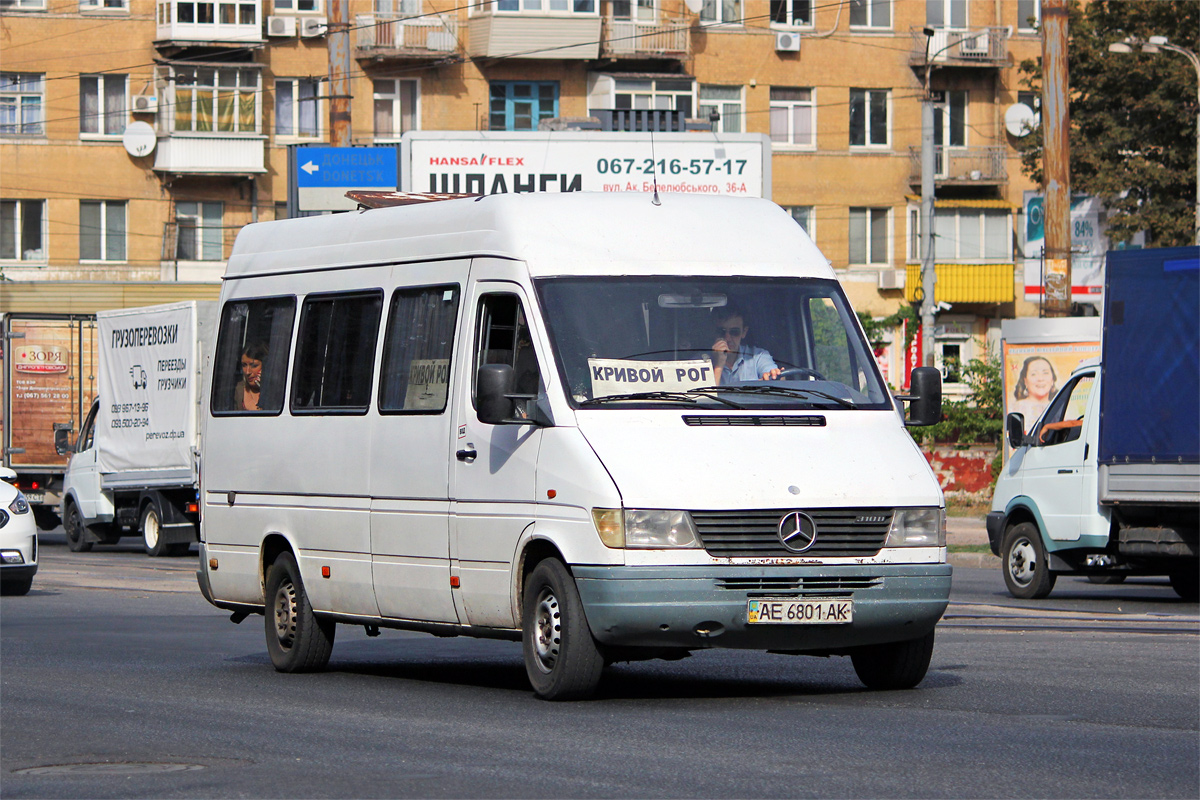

{"left": 521, "top": 558, "right": 604, "bottom": 700}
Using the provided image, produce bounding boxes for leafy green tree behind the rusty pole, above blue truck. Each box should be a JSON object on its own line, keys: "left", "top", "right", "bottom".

{"left": 1020, "top": 0, "right": 1200, "bottom": 247}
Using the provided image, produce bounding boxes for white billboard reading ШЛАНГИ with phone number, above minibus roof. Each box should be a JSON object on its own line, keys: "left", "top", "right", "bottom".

{"left": 401, "top": 131, "right": 770, "bottom": 198}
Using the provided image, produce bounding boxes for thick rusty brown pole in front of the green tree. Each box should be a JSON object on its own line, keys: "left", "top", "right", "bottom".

{"left": 1042, "top": 0, "right": 1070, "bottom": 317}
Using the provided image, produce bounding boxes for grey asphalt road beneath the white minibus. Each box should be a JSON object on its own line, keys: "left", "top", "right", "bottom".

{"left": 0, "top": 536, "right": 1200, "bottom": 799}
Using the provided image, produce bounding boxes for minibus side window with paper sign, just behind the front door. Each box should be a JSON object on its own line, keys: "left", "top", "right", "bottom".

{"left": 379, "top": 285, "right": 458, "bottom": 414}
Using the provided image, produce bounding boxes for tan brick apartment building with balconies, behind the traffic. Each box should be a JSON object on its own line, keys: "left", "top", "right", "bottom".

{"left": 0, "top": 0, "right": 1040, "bottom": 393}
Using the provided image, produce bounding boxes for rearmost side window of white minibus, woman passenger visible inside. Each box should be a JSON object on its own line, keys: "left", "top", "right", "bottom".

{"left": 211, "top": 297, "right": 296, "bottom": 415}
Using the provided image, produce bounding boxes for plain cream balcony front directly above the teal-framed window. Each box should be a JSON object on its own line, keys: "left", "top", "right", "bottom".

{"left": 469, "top": 12, "right": 600, "bottom": 61}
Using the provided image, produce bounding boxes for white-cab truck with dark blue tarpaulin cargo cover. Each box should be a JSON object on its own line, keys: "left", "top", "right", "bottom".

{"left": 988, "top": 247, "right": 1200, "bottom": 600}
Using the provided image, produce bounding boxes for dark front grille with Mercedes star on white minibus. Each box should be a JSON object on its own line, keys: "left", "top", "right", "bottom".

{"left": 691, "top": 509, "right": 893, "bottom": 558}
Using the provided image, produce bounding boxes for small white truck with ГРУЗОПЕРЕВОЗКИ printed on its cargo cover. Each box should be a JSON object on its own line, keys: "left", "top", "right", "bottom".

{"left": 55, "top": 301, "right": 216, "bottom": 555}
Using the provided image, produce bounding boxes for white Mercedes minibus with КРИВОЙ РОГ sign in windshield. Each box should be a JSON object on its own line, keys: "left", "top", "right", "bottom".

{"left": 198, "top": 193, "right": 950, "bottom": 699}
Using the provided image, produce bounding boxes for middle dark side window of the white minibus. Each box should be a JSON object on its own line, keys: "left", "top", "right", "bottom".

{"left": 292, "top": 291, "right": 383, "bottom": 414}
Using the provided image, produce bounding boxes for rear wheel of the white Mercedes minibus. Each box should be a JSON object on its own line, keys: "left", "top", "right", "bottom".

{"left": 264, "top": 553, "right": 337, "bottom": 672}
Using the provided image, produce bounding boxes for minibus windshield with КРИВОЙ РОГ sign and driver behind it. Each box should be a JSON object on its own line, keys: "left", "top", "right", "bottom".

{"left": 535, "top": 276, "right": 892, "bottom": 409}
